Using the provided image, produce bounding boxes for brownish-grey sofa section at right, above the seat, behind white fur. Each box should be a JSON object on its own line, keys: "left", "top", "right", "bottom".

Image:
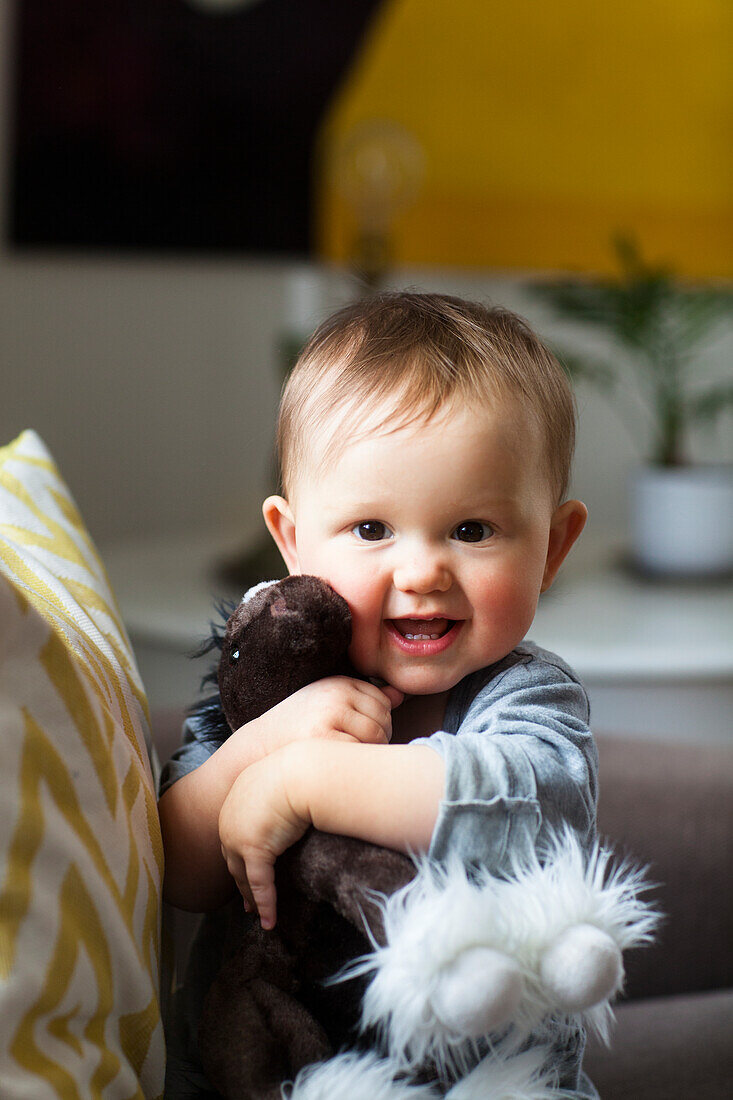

{"left": 597, "top": 735, "right": 733, "bottom": 998}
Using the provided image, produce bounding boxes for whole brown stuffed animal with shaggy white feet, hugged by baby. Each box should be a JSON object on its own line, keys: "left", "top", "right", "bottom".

{"left": 189, "top": 576, "right": 657, "bottom": 1100}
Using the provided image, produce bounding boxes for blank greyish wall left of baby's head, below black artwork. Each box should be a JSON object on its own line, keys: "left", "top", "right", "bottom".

{"left": 0, "top": 251, "right": 290, "bottom": 540}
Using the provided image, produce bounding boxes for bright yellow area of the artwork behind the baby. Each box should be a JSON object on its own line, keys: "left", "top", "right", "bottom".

{"left": 317, "top": 0, "right": 733, "bottom": 276}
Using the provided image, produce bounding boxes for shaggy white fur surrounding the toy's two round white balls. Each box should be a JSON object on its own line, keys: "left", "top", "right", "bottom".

{"left": 341, "top": 829, "right": 658, "bottom": 1071}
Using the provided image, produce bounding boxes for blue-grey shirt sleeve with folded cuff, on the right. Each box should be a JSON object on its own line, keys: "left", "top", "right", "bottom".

{"left": 413, "top": 651, "right": 598, "bottom": 872}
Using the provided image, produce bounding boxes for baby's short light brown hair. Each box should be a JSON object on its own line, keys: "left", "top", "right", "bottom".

{"left": 277, "top": 290, "right": 576, "bottom": 503}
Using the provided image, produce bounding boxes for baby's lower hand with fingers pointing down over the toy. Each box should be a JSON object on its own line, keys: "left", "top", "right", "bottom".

{"left": 219, "top": 752, "right": 310, "bottom": 928}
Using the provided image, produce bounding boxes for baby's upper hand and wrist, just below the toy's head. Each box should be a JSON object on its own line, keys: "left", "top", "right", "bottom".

{"left": 250, "top": 677, "right": 403, "bottom": 752}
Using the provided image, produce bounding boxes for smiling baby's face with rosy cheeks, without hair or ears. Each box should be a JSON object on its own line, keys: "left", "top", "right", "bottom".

{"left": 265, "top": 403, "right": 582, "bottom": 694}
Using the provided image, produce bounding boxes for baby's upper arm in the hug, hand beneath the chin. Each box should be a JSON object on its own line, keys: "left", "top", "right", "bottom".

{"left": 158, "top": 677, "right": 402, "bottom": 911}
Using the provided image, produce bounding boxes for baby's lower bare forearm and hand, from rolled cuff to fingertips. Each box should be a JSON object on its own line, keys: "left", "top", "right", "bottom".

{"left": 219, "top": 740, "right": 445, "bottom": 928}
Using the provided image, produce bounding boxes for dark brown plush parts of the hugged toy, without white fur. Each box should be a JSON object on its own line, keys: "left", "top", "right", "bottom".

{"left": 191, "top": 576, "right": 415, "bottom": 1100}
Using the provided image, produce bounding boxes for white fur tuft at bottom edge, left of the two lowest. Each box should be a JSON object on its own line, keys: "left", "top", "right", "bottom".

{"left": 283, "top": 1053, "right": 438, "bottom": 1100}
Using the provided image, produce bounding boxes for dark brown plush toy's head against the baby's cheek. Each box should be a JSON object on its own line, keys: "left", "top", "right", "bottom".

{"left": 198, "top": 575, "right": 354, "bottom": 729}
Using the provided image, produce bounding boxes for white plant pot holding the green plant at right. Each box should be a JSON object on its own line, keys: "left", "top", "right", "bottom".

{"left": 631, "top": 465, "right": 733, "bottom": 578}
